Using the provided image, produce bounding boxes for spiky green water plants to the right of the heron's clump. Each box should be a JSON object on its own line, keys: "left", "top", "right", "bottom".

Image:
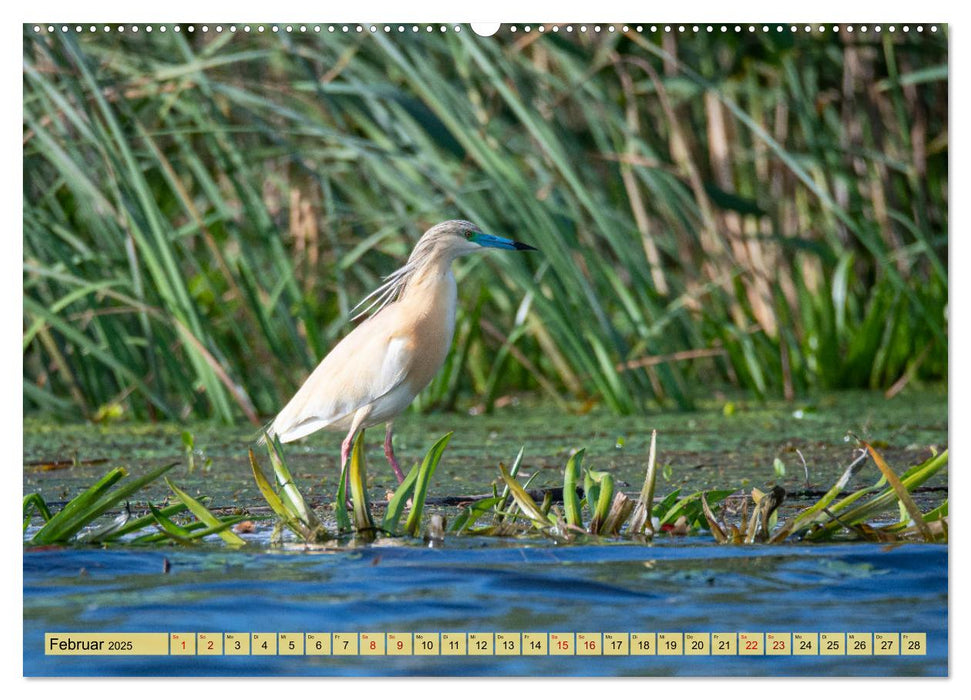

{"left": 453, "top": 432, "right": 948, "bottom": 544}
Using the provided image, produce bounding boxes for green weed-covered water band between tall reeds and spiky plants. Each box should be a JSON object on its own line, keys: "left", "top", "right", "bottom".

{"left": 24, "top": 393, "right": 948, "bottom": 507}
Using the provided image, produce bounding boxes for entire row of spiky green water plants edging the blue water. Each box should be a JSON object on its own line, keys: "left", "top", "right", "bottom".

{"left": 24, "top": 431, "right": 948, "bottom": 546}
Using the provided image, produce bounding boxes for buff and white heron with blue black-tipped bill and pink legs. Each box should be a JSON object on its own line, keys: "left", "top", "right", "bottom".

{"left": 267, "top": 221, "right": 536, "bottom": 483}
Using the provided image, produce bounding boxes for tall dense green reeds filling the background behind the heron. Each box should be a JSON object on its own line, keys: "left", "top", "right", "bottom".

{"left": 23, "top": 26, "right": 948, "bottom": 421}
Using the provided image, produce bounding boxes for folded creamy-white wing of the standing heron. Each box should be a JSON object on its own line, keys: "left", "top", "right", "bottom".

{"left": 269, "top": 307, "right": 414, "bottom": 442}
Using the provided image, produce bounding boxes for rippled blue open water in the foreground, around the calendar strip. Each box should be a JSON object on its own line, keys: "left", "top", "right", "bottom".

{"left": 23, "top": 537, "right": 948, "bottom": 676}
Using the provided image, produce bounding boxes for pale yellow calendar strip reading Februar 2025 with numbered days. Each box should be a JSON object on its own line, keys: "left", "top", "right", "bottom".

{"left": 44, "top": 632, "right": 927, "bottom": 657}
